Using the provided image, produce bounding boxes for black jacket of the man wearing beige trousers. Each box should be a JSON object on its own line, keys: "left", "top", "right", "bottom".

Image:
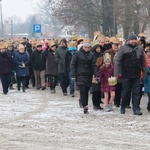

{"left": 31, "top": 50, "right": 46, "bottom": 71}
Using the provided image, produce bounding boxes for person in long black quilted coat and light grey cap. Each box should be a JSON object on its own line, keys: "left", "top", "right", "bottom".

{"left": 71, "top": 43, "right": 97, "bottom": 114}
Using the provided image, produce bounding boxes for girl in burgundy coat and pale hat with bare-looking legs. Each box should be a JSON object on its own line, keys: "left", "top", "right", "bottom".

{"left": 99, "top": 53, "right": 115, "bottom": 112}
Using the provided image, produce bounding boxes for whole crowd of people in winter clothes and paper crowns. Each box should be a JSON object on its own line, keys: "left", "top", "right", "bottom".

{"left": 0, "top": 32, "right": 150, "bottom": 115}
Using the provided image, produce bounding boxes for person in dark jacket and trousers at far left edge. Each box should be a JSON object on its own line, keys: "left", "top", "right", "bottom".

{"left": 0, "top": 44, "right": 14, "bottom": 94}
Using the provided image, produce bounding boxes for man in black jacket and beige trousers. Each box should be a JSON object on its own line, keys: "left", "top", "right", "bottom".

{"left": 31, "top": 43, "right": 46, "bottom": 90}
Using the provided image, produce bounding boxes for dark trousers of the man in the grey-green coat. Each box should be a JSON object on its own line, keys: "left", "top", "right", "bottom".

{"left": 59, "top": 73, "right": 68, "bottom": 93}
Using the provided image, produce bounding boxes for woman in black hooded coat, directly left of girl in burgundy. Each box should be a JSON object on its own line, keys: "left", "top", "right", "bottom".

{"left": 91, "top": 44, "right": 103, "bottom": 110}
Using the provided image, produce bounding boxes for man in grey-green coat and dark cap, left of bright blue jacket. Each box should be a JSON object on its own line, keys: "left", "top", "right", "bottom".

{"left": 54, "top": 38, "right": 68, "bottom": 96}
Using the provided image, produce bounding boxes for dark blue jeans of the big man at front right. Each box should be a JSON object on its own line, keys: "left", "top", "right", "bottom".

{"left": 121, "top": 78, "right": 140, "bottom": 112}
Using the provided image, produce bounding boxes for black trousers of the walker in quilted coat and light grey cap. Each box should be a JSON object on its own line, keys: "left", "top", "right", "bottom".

{"left": 79, "top": 85, "right": 90, "bottom": 107}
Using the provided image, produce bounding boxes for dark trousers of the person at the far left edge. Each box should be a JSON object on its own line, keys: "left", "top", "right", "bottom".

{"left": 0, "top": 73, "right": 11, "bottom": 94}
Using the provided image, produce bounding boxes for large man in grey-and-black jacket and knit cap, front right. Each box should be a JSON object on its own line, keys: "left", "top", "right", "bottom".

{"left": 114, "top": 34, "right": 146, "bottom": 115}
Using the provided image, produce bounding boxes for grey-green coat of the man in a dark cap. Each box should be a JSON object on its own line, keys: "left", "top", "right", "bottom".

{"left": 54, "top": 47, "right": 68, "bottom": 74}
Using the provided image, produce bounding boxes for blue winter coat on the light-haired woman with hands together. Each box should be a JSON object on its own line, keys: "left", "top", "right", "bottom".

{"left": 15, "top": 52, "right": 29, "bottom": 77}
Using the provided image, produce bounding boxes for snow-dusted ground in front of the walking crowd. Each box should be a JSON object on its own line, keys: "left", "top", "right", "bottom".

{"left": 0, "top": 87, "right": 150, "bottom": 150}
